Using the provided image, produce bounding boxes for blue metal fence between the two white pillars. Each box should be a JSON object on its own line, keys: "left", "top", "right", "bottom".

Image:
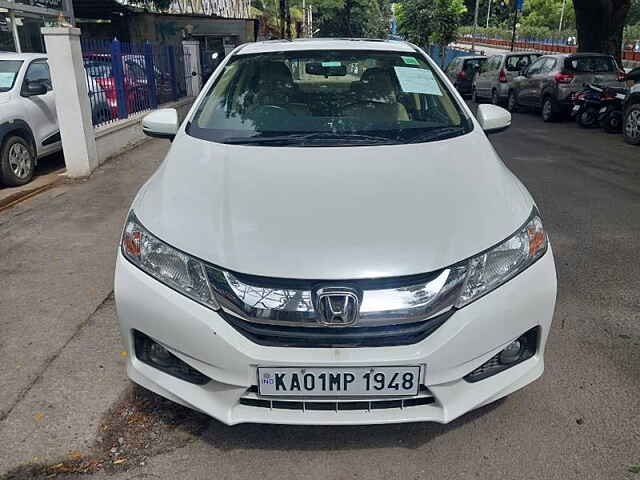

{"left": 82, "top": 39, "right": 194, "bottom": 126}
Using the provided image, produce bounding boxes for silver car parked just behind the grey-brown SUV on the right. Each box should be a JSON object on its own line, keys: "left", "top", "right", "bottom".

{"left": 471, "top": 52, "right": 541, "bottom": 105}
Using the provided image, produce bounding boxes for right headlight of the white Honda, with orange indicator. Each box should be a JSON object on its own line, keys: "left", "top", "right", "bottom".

{"left": 456, "top": 208, "right": 549, "bottom": 308}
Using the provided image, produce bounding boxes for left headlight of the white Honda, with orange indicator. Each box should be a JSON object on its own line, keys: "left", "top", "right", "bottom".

{"left": 122, "top": 212, "right": 220, "bottom": 310}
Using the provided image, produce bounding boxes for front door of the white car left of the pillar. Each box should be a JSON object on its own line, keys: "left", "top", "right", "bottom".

{"left": 20, "top": 59, "right": 60, "bottom": 155}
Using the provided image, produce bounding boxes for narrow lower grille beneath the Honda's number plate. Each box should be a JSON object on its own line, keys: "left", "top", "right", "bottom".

{"left": 239, "top": 386, "right": 436, "bottom": 412}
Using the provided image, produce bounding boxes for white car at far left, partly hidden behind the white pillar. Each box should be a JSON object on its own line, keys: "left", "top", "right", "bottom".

{"left": 0, "top": 52, "right": 109, "bottom": 186}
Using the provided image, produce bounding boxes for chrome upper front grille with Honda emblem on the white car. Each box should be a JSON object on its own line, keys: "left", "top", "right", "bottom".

{"left": 206, "top": 266, "right": 466, "bottom": 347}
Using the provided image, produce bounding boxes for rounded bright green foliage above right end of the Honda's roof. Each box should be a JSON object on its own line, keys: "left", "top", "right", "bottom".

{"left": 396, "top": 0, "right": 467, "bottom": 45}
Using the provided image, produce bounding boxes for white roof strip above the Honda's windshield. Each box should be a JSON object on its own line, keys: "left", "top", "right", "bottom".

{"left": 236, "top": 38, "right": 415, "bottom": 55}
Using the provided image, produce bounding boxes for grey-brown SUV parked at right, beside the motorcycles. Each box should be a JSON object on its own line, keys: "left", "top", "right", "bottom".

{"left": 507, "top": 53, "right": 624, "bottom": 122}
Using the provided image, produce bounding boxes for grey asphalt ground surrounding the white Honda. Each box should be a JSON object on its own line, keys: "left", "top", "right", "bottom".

{"left": 0, "top": 106, "right": 640, "bottom": 480}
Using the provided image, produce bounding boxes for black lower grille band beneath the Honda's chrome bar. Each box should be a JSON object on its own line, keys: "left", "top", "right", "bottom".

{"left": 220, "top": 309, "right": 455, "bottom": 348}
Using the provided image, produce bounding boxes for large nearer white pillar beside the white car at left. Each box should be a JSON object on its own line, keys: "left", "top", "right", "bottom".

{"left": 41, "top": 27, "right": 98, "bottom": 177}
